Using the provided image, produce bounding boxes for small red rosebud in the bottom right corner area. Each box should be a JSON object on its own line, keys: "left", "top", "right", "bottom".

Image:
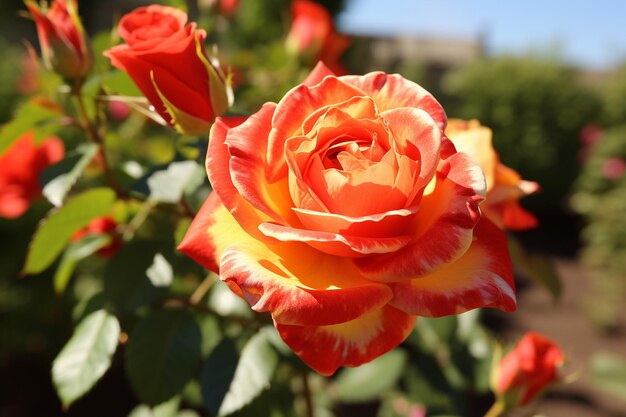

{"left": 494, "top": 332, "right": 564, "bottom": 407}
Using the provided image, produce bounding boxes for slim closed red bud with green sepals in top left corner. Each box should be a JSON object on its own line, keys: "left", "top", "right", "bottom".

{"left": 26, "top": 0, "right": 93, "bottom": 80}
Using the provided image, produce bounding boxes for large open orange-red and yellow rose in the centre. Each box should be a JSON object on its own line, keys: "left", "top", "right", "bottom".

{"left": 179, "top": 64, "right": 515, "bottom": 375}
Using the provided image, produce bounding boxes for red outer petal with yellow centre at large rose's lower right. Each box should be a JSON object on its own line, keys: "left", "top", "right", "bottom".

{"left": 390, "top": 218, "right": 515, "bottom": 317}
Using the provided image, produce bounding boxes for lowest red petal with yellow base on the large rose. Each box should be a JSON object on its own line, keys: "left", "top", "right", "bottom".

{"left": 275, "top": 306, "right": 416, "bottom": 375}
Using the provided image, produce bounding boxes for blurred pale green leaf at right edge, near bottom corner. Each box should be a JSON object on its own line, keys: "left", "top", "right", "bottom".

{"left": 590, "top": 352, "right": 626, "bottom": 401}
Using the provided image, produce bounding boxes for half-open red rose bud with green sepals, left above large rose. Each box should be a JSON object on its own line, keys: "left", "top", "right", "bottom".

{"left": 104, "top": 4, "right": 229, "bottom": 135}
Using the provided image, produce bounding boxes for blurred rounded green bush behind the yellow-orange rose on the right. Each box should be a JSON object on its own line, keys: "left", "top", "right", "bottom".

{"left": 443, "top": 57, "right": 599, "bottom": 210}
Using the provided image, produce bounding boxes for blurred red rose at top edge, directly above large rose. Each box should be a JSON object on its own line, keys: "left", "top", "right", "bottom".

{"left": 287, "top": 0, "right": 350, "bottom": 75}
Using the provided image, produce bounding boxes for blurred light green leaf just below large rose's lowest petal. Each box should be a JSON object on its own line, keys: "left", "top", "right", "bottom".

{"left": 335, "top": 349, "right": 407, "bottom": 403}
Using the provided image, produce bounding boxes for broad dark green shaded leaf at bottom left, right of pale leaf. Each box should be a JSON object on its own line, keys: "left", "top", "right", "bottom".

{"left": 126, "top": 310, "right": 202, "bottom": 405}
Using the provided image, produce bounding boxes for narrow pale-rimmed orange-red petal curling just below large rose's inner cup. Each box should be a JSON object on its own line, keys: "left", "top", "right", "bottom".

{"left": 259, "top": 223, "right": 411, "bottom": 257}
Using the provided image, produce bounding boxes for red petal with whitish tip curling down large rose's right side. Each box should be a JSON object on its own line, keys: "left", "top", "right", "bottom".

{"left": 356, "top": 153, "right": 485, "bottom": 282}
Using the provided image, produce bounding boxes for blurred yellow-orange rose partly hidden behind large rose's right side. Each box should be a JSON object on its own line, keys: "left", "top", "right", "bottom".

{"left": 445, "top": 119, "right": 540, "bottom": 230}
